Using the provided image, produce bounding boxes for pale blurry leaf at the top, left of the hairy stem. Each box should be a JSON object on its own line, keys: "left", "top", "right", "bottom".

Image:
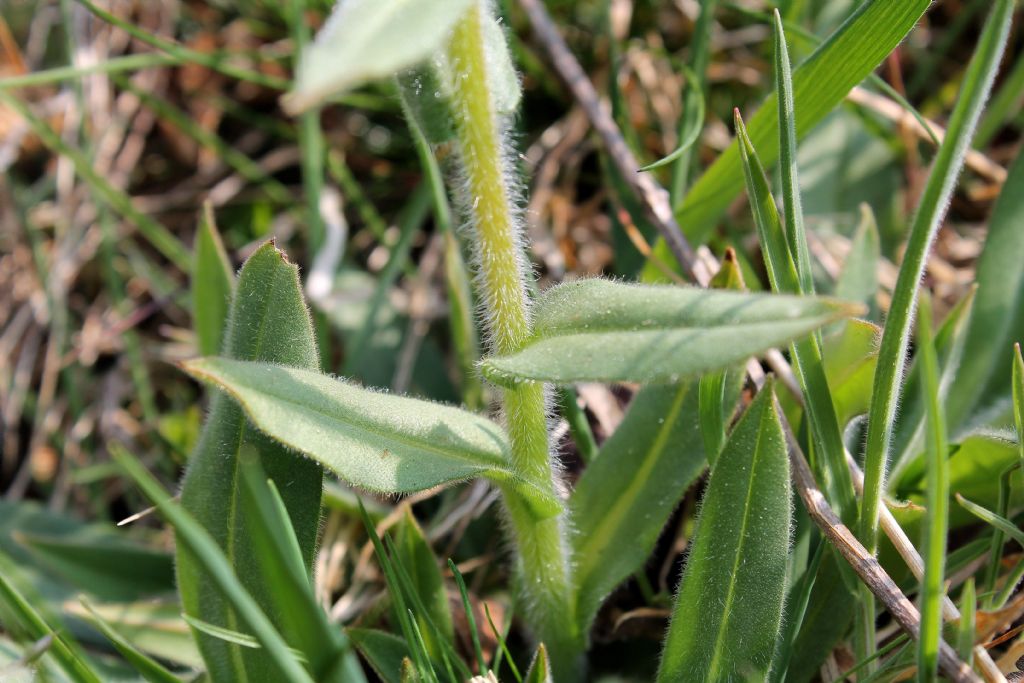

{"left": 282, "top": 0, "right": 473, "bottom": 116}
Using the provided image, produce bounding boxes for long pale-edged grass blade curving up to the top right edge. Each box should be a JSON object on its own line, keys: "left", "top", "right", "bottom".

{"left": 860, "top": 0, "right": 1014, "bottom": 552}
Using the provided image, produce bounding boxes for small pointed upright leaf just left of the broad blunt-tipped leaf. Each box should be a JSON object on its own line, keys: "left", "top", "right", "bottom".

{"left": 191, "top": 202, "right": 234, "bottom": 355}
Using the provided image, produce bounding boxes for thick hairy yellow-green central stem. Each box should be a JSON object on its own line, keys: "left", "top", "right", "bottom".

{"left": 449, "top": 2, "right": 583, "bottom": 680}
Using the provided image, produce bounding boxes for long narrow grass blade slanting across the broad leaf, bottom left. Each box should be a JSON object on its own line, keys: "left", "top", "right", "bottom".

{"left": 112, "top": 450, "right": 312, "bottom": 683}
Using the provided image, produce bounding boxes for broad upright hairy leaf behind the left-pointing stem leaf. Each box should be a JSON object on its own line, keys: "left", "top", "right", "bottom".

{"left": 177, "top": 243, "right": 324, "bottom": 681}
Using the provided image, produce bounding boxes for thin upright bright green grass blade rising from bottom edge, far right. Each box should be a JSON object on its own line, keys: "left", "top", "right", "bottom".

{"left": 918, "top": 296, "right": 949, "bottom": 683}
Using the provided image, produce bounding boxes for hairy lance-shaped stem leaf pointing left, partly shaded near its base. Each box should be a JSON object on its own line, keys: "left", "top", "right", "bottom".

{"left": 182, "top": 358, "right": 561, "bottom": 515}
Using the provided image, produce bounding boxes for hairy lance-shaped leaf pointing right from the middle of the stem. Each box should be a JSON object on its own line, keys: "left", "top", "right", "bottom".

{"left": 481, "top": 279, "right": 860, "bottom": 385}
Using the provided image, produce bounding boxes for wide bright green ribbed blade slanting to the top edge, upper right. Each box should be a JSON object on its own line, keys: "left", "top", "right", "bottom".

{"left": 655, "top": 0, "right": 931, "bottom": 255}
